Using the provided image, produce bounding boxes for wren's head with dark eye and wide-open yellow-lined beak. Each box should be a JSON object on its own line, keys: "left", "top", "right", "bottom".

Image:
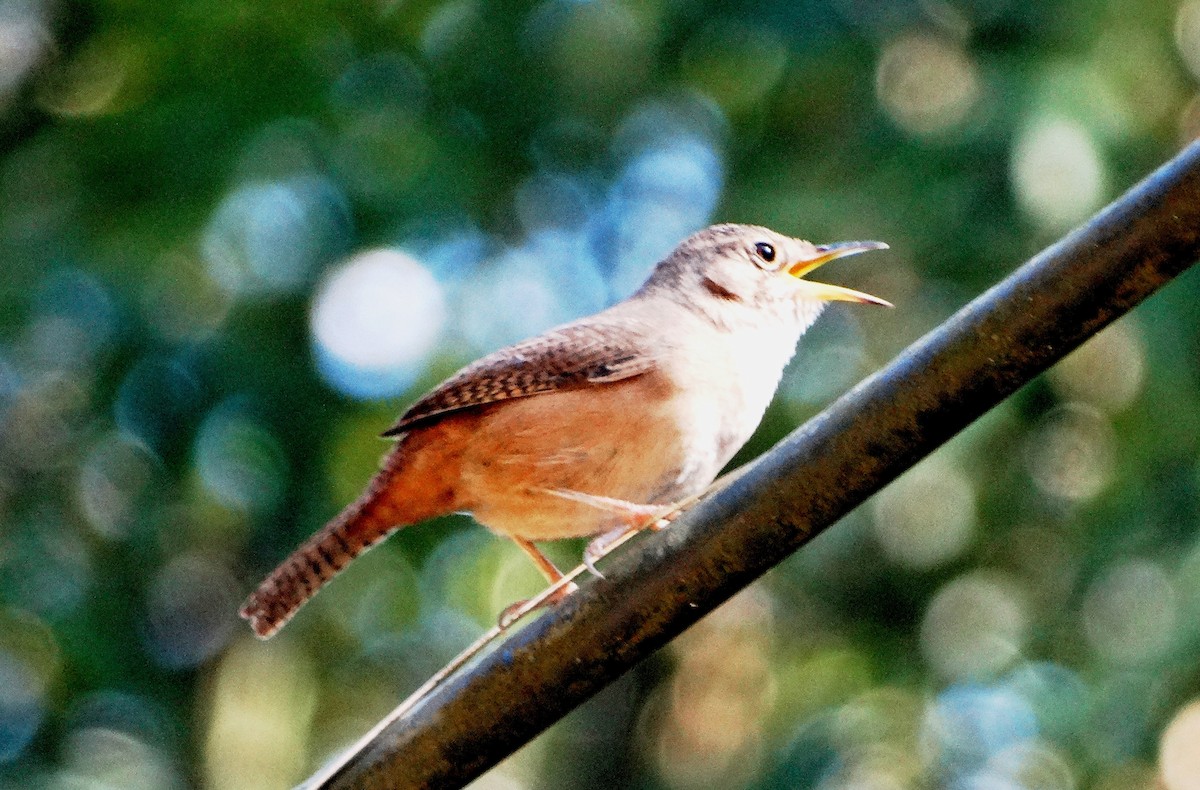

{"left": 643, "top": 225, "right": 892, "bottom": 323}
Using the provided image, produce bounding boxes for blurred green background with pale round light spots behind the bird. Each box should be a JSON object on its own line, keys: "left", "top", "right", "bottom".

{"left": 0, "top": 0, "right": 1200, "bottom": 790}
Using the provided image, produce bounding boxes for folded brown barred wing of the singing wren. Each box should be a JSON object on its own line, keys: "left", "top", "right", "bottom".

{"left": 383, "top": 318, "right": 654, "bottom": 436}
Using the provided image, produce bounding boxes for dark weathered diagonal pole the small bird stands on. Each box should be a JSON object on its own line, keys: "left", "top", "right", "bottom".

{"left": 304, "top": 138, "right": 1200, "bottom": 788}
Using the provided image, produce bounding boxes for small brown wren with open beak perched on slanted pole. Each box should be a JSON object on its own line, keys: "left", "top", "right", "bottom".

{"left": 240, "top": 223, "right": 890, "bottom": 639}
